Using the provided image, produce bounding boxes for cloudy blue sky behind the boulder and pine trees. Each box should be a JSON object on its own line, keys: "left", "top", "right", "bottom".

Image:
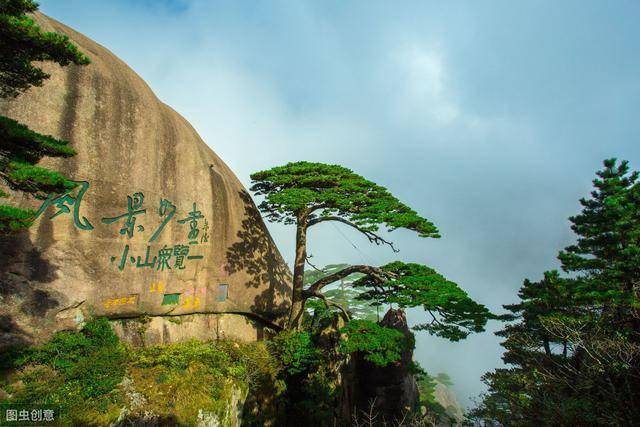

{"left": 41, "top": 0, "right": 640, "bottom": 404}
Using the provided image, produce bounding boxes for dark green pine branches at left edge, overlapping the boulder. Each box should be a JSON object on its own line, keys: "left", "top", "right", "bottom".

{"left": 0, "top": 0, "right": 89, "bottom": 234}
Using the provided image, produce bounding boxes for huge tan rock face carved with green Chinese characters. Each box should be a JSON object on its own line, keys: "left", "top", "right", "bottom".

{"left": 0, "top": 14, "right": 290, "bottom": 350}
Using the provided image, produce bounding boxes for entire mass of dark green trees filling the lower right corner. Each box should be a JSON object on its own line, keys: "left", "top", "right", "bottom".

{"left": 472, "top": 159, "right": 640, "bottom": 426}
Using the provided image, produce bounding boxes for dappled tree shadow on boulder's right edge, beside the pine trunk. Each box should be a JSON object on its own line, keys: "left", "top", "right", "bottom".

{"left": 225, "top": 190, "right": 291, "bottom": 320}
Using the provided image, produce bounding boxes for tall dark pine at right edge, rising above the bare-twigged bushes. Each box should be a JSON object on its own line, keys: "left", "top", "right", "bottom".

{"left": 558, "top": 159, "right": 640, "bottom": 333}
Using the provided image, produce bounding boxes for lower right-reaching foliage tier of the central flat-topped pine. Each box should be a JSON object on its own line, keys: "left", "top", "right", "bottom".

{"left": 354, "top": 261, "right": 491, "bottom": 341}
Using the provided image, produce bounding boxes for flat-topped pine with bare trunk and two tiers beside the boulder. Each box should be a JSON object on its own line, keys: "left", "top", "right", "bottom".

{"left": 251, "top": 162, "right": 491, "bottom": 334}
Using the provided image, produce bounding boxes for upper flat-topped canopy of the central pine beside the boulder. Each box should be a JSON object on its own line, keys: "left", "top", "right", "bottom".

{"left": 251, "top": 162, "right": 439, "bottom": 237}
